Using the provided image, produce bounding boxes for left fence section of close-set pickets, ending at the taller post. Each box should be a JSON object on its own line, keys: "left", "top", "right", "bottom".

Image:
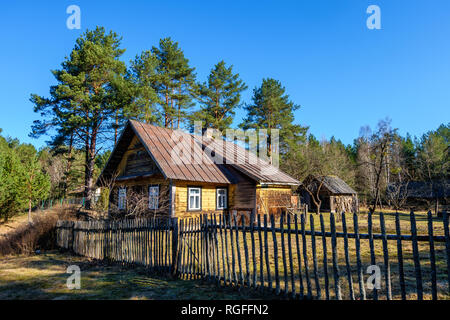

{"left": 56, "top": 219, "right": 178, "bottom": 273}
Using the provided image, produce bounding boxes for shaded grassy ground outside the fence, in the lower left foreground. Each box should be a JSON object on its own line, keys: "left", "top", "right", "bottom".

{"left": 0, "top": 252, "right": 270, "bottom": 300}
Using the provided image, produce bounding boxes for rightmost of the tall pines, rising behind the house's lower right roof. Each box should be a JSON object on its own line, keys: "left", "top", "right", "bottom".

{"left": 240, "top": 78, "right": 307, "bottom": 162}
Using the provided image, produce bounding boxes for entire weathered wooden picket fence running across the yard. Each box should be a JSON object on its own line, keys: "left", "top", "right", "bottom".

{"left": 57, "top": 212, "right": 450, "bottom": 300}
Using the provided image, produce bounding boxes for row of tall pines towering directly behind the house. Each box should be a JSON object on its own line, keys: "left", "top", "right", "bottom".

{"left": 31, "top": 27, "right": 306, "bottom": 208}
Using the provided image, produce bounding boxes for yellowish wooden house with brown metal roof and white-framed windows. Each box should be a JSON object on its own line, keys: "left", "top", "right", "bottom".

{"left": 97, "top": 120, "right": 300, "bottom": 217}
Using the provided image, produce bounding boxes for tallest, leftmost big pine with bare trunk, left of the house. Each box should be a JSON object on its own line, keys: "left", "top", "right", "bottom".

{"left": 31, "top": 27, "right": 126, "bottom": 209}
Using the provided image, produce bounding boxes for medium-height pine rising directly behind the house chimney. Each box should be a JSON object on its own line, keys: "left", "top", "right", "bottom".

{"left": 191, "top": 61, "right": 247, "bottom": 132}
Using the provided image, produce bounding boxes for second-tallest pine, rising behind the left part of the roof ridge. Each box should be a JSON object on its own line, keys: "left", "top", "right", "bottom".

{"left": 151, "top": 38, "right": 196, "bottom": 128}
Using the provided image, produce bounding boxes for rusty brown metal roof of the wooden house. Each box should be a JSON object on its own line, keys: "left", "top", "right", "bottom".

{"left": 101, "top": 120, "right": 300, "bottom": 185}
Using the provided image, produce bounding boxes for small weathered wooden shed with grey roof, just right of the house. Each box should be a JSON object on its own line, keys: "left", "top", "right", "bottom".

{"left": 298, "top": 175, "right": 359, "bottom": 212}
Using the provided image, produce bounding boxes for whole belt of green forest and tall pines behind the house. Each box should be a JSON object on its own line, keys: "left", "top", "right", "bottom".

{"left": 0, "top": 27, "right": 450, "bottom": 220}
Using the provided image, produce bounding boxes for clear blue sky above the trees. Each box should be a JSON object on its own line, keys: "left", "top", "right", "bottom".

{"left": 0, "top": 0, "right": 450, "bottom": 147}
